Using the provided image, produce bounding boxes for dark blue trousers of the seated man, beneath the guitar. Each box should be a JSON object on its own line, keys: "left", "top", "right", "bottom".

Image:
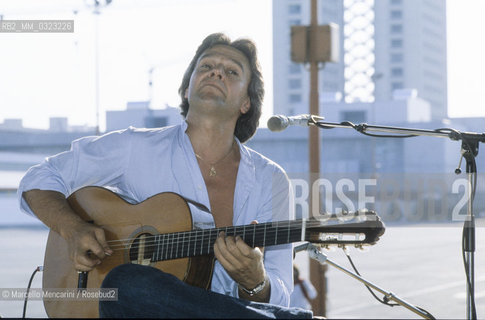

{"left": 99, "top": 264, "right": 312, "bottom": 319}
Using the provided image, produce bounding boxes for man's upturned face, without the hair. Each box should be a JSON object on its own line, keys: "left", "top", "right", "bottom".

{"left": 185, "top": 45, "right": 251, "bottom": 119}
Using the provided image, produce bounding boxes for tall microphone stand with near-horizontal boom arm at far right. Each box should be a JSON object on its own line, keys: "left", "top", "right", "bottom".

{"left": 308, "top": 116, "right": 485, "bottom": 319}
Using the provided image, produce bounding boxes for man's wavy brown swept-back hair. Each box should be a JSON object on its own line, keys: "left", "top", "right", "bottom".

{"left": 179, "top": 33, "right": 264, "bottom": 142}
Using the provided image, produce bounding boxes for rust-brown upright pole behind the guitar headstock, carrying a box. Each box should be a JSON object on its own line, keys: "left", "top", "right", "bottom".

{"left": 308, "top": 0, "right": 327, "bottom": 316}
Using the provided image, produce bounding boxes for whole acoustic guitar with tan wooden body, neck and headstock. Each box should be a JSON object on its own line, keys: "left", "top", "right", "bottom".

{"left": 42, "top": 187, "right": 385, "bottom": 318}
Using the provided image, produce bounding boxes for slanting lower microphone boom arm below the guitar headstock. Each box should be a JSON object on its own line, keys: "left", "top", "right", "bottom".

{"left": 293, "top": 242, "right": 434, "bottom": 319}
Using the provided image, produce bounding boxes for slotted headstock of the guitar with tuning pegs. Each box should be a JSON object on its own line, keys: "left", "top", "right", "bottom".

{"left": 304, "top": 210, "right": 385, "bottom": 247}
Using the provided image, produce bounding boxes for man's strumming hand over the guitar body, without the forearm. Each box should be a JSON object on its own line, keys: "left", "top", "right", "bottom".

{"left": 62, "top": 222, "right": 113, "bottom": 271}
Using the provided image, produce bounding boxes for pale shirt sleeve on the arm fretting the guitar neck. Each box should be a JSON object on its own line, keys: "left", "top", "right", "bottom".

{"left": 263, "top": 165, "right": 294, "bottom": 307}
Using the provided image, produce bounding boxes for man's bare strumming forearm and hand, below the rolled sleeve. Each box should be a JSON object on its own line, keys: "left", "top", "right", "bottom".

{"left": 22, "top": 189, "right": 113, "bottom": 271}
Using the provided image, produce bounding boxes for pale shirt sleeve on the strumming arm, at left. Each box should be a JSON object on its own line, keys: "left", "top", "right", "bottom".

{"left": 17, "top": 129, "right": 131, "bottom": 215}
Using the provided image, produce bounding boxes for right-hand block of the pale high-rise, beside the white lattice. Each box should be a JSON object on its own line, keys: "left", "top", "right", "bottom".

{"left": 374, "top": 0, "right": 447, "bottom": 120}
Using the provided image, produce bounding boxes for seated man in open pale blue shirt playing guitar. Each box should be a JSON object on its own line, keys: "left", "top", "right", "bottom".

{"left": 19, "top": 34, "right": 312, "bottom": 318}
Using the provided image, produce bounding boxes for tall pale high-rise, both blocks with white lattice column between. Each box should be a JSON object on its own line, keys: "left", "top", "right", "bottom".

{"left": 273, "top": 0, "right": 447, "bottom": 120}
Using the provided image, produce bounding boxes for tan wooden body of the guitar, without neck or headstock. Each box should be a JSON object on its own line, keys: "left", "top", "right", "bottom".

{"left": 42, "top": 187, "right": 214, "bottom": 318}
